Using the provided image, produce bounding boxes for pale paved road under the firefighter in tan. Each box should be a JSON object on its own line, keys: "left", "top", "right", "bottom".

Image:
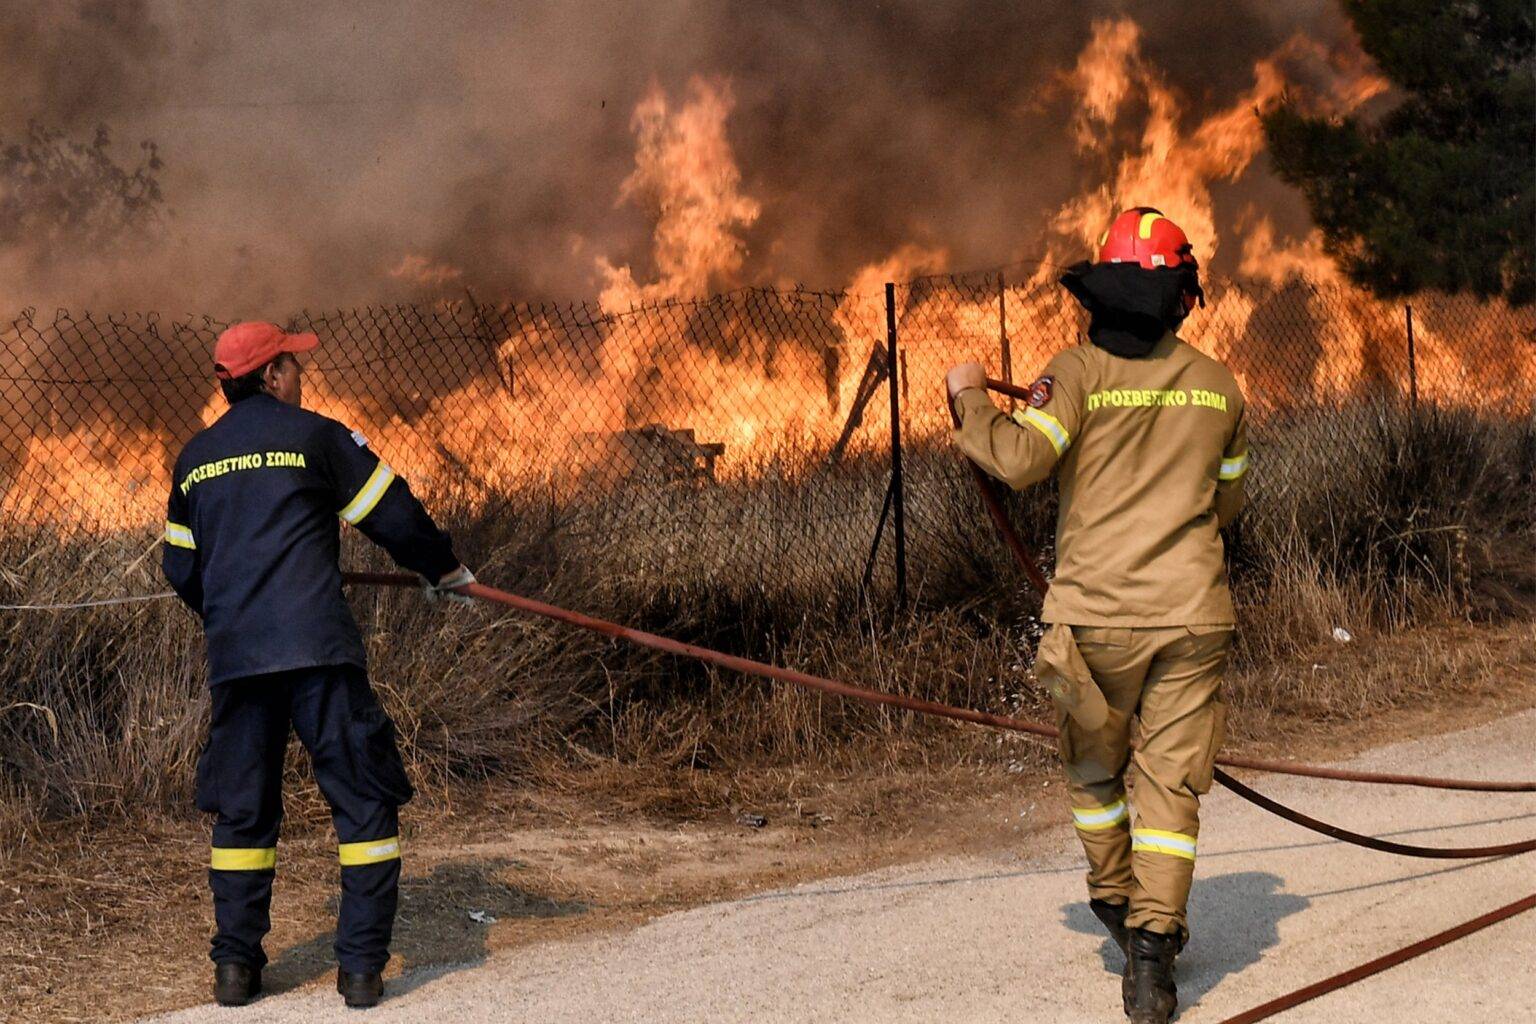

{"left": 146, "top": 712, "right": 1536, "bottom": 1024}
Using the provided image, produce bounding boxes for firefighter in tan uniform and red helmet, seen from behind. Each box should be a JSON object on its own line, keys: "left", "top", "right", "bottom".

{"left": 949, "top": 207, "right": 1249, "bottom": 1024}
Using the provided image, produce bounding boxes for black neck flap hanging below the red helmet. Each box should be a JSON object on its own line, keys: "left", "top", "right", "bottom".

{"left": 1061, "top": 256, "right": 1206, "bottom": 359}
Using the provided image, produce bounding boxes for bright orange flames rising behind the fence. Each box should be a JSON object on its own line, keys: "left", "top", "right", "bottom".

{"left": 0, "top": 18, "right": 1536, "bottom": 524}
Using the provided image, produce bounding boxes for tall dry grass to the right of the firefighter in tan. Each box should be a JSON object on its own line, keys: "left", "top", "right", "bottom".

{"left": 1233, "top": 404, "right": 1536, "bottom": 628}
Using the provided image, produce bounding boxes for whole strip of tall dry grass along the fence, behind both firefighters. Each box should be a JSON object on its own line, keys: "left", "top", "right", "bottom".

{"left": 0, "top": 407, "right": 1536, "bottom": 866}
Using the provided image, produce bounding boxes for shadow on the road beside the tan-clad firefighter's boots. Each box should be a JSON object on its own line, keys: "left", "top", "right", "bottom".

{"left": 1061, "top": 870, "right": 1312, "bottom": 1007}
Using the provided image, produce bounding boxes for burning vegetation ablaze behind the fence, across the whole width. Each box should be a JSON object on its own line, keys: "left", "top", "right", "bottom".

{"left": 0, "top": 18, "right": 1536, "bottom": 525}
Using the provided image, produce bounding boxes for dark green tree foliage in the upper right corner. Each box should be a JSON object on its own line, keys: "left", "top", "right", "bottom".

{"left": 1264, "top": 0, "right": 1536, "bottom": 306}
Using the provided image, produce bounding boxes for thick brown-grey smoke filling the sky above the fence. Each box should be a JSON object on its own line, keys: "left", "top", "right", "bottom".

{"left": 0, "top": 0, "right": 1358, "bottom": 318}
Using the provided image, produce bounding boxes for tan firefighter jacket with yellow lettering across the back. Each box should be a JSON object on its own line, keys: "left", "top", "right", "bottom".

{"left": 954, "top": 333, "right": 1247, "bottom": 626}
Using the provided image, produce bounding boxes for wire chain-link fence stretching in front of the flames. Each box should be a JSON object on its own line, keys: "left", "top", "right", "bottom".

{"left": 0, "top": 272, "right": 1536, "bottom": 604}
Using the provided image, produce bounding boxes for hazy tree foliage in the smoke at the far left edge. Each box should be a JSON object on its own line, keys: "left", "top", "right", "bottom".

{"left": 0, "top": 121, "right": 164, "bottom": 256}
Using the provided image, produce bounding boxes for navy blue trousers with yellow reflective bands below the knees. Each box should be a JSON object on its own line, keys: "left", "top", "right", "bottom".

{"left": 197, "top": 665, "right": 412, "bottom": 972}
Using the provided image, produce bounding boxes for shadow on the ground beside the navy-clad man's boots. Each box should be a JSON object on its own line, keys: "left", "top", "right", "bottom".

{"left": 261, "top": 858, "right": 587, "bottom": 999}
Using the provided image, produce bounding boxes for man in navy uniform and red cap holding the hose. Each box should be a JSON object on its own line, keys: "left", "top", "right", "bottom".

{"left": 163, "top": 322, "right": 475, "bottom": 1007}
